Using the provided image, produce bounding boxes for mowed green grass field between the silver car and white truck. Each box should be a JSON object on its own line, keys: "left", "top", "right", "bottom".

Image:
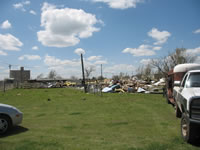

{"left": 0, "top": 88, "right": 199, "bottom": 150}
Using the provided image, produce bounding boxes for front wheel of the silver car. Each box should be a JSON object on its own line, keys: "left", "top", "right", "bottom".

{"left": 0, "top": 115, "right": 11, "bottom": 135}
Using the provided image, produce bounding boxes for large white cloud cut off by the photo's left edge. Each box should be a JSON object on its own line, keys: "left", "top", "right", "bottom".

{"left": 0, "top": 34, "right": 23, "bottom": 51}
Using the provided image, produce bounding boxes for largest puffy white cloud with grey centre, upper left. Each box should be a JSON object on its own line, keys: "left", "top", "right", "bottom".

{"left": 37, "top": 3, "right": 101, "bottom": 47}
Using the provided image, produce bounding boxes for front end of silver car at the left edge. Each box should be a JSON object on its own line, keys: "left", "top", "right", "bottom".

{"left": 0, "top": 103, "right": 23, "bottom": 134}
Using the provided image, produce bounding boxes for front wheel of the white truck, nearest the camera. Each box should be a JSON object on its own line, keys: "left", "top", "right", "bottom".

{"left": 181, "top": 114, "right": 197, "bottom": 143}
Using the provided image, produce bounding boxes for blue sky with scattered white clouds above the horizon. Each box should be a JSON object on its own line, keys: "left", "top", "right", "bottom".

{"left": 0, "top": 0, "right": 200, "bottom": 79}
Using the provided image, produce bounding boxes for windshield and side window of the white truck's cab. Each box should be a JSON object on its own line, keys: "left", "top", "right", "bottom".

{"left": 186, "top": 72, "right": 200, "bottom": 88}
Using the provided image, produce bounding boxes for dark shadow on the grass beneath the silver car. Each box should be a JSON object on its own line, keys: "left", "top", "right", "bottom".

{"left": 0, "top": 126, "right": 28, "bottom": 138}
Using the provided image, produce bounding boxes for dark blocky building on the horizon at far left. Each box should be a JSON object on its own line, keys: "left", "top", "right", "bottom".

{"left": 10, "top": 67, "right": 31, "bottom": 83}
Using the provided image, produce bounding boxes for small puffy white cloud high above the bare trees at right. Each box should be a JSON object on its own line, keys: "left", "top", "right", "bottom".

{"left": 148, "top": 28, "right": 171, "bottom": 45}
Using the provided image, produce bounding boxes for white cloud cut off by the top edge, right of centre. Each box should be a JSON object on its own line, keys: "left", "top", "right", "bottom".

{"left": 92, "top": 0, "right": 143, "bottom": 9}
